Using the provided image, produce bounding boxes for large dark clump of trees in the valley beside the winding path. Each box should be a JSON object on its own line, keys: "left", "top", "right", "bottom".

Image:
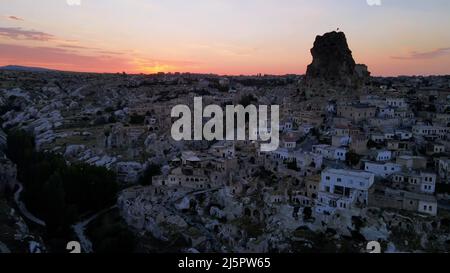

{"left": 6, "top": 131, "right": 123, "bottom": 248}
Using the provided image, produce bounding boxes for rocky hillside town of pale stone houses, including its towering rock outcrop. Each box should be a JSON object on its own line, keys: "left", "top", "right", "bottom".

{"left": 0, "top": 32, "right": 450, "bottom": 253}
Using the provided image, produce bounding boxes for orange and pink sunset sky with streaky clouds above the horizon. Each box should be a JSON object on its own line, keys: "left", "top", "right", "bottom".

{"left": 0, "top": 0, "right": 450, "bottom": 76}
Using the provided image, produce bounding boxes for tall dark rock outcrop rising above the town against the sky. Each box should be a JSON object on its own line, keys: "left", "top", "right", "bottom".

{"left": 306, "top": 31, "right": 370, "bottom": 87}
